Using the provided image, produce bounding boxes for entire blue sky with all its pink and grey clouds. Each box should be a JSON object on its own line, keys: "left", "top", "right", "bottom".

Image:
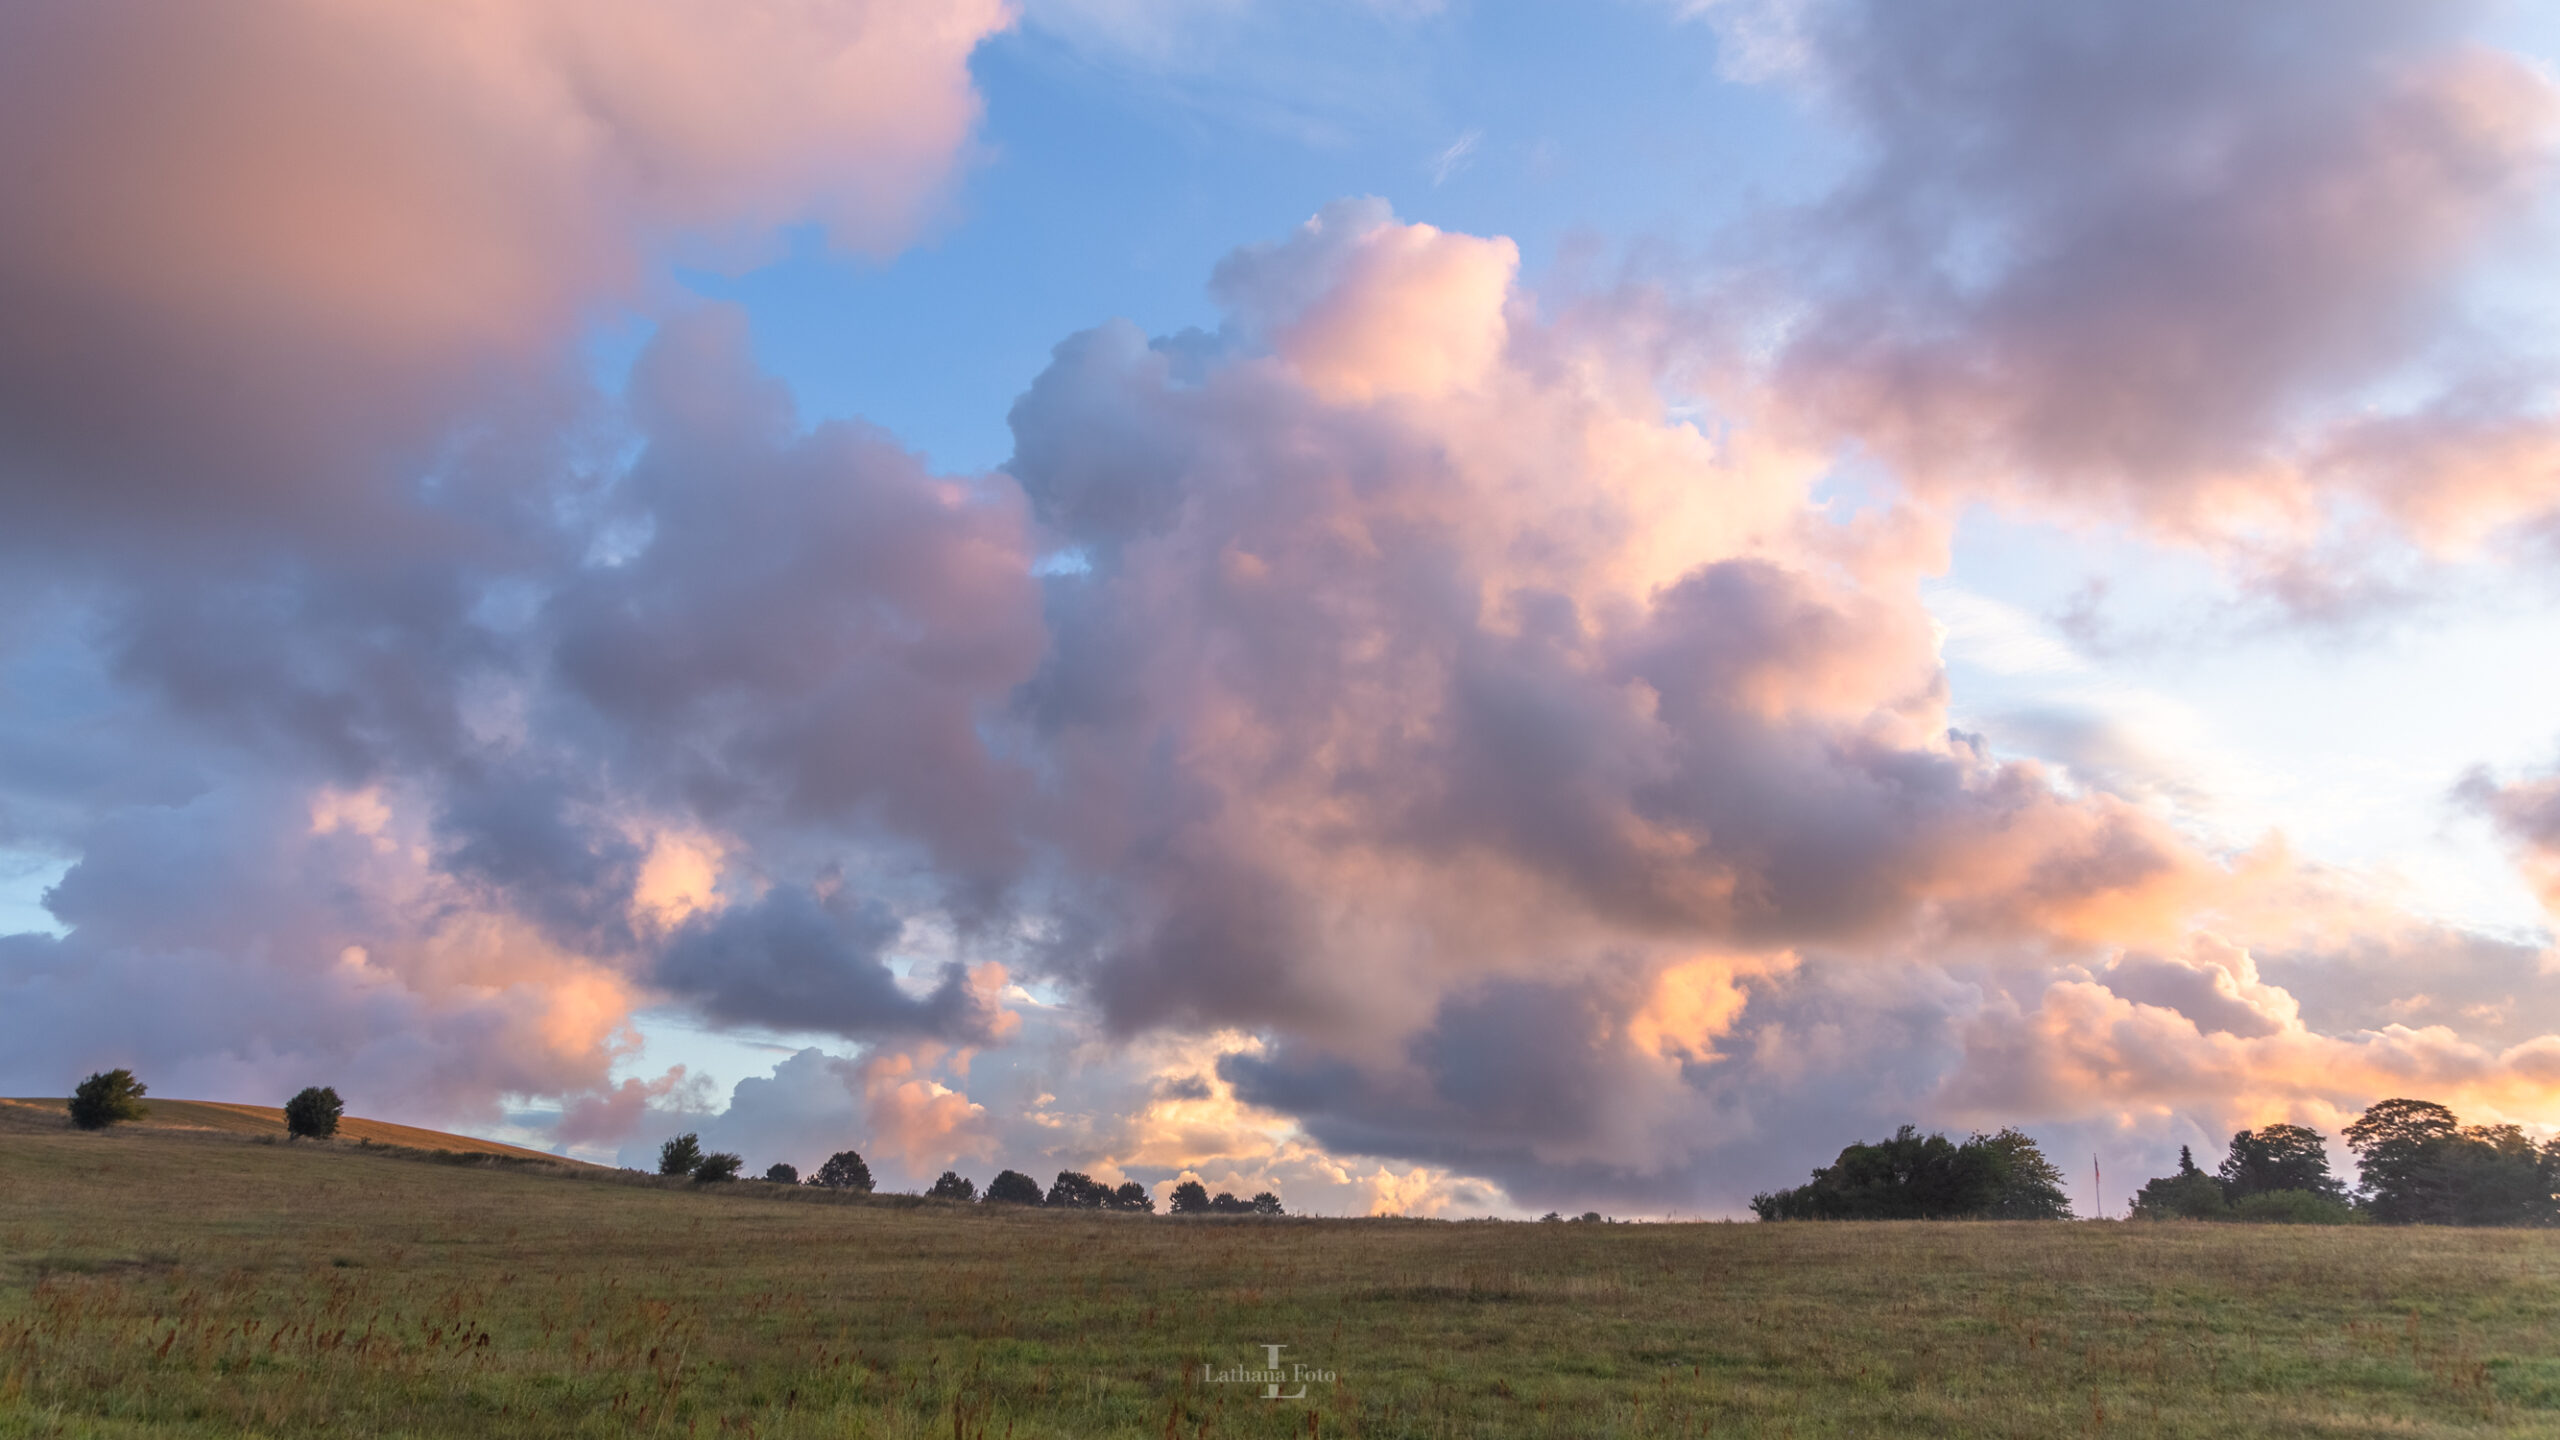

{"left": 0, "top": 0, "right": 2560, "bottom": 1217}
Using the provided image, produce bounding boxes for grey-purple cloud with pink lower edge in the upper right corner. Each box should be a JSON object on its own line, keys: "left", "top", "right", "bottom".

{"left": 1713, "top": 0, "right": 2560, "bottom": 548}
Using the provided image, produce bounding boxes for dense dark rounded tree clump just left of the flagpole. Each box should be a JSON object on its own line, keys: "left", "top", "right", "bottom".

{"left": 1751, "top": 1125, "right": 2071, "bottom": 1220}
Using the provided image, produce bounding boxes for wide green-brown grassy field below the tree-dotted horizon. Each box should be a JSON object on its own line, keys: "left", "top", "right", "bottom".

{"left": 0, "top": 1096, "right": 2560, "bottom": 1440}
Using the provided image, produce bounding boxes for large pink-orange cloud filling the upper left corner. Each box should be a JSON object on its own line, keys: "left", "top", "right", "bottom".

{"left": 0, "top": 0, "right": 1006, "bottom": 546}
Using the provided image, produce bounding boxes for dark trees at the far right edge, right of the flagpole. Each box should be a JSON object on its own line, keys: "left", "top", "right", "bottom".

{"left": 2132, "top": 1099, "right": 2560, "bottom": 1225}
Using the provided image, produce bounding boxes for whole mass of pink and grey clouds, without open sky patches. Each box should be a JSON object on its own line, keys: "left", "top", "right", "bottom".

{"left": 0, "top": 0, "right": 2560, "bottom": 1209}
